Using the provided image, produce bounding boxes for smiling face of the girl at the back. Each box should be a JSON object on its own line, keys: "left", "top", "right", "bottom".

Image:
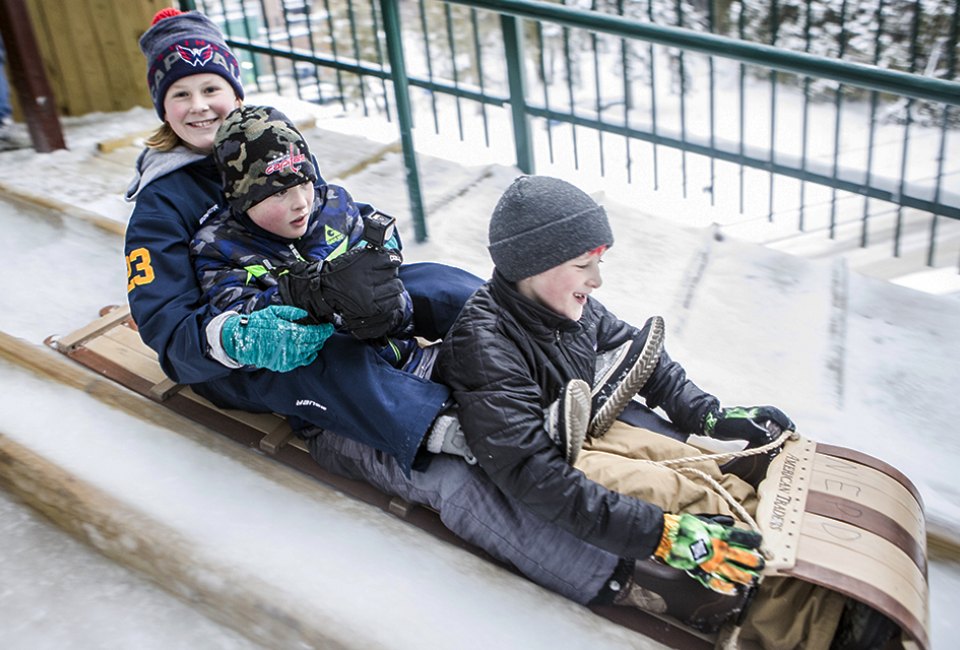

{"left": 163, "top": 72, "right": 240, "bottom": 153}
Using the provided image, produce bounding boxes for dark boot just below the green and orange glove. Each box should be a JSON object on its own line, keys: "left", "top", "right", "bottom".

{"left": 614, "top": 559, "right": 753, "bottom": 633}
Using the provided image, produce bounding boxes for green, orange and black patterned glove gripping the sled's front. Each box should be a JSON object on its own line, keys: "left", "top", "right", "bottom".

{"left": 653, "top": 514, "right": 764, "bottom": 596}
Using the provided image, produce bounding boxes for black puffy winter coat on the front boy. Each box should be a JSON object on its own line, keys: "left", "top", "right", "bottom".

{"left": 437, "top": 271, "right": 718, "bottom": 558}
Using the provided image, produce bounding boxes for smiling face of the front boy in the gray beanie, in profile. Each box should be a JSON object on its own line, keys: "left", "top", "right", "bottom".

{"left": 517, "top": 246, "right": 606, "bottom": 320}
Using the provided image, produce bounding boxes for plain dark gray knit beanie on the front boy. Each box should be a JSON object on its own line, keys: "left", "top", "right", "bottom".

{"left": 488, "top": 176, "right": 613, "bottom": 282}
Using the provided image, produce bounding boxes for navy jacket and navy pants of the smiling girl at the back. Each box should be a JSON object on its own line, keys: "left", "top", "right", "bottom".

{"left": 124, "top": 149, "right": 472, "bottom": 472}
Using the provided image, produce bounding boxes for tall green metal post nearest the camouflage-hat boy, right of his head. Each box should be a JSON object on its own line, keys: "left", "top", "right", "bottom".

{"left": 380, "top": 0, "right": 427, "bottom": 242}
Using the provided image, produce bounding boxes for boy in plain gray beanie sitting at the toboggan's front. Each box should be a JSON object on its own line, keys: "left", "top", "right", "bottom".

{"left": 436, "top": 176, "right": 876, "bottom": 649}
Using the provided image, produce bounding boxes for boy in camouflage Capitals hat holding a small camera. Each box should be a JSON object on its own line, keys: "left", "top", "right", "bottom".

{"left": 191, "top": 106, "right": 419, "bottom": 367}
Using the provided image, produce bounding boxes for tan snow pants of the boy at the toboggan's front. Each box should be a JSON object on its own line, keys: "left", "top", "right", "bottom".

{"left": 575, "top": 421, "right": 845, "bottom": 650}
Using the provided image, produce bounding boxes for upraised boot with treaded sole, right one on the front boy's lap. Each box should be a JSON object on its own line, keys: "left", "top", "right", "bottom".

{"left": 588, "top": 316, "right": 664, "bottom": 438}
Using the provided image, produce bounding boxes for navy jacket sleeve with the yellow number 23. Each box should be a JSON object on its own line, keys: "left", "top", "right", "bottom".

{"left": 124, "top": 173, "right": 230, "bottom": 384}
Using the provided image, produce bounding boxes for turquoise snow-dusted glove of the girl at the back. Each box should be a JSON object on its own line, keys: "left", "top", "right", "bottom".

{"left": 220, "top": 305, "right": 333, "bottom": 372}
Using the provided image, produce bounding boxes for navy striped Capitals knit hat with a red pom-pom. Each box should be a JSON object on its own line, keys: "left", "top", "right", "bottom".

{"left": 140, "top": 9, "right": 243, "bottom": 120}
